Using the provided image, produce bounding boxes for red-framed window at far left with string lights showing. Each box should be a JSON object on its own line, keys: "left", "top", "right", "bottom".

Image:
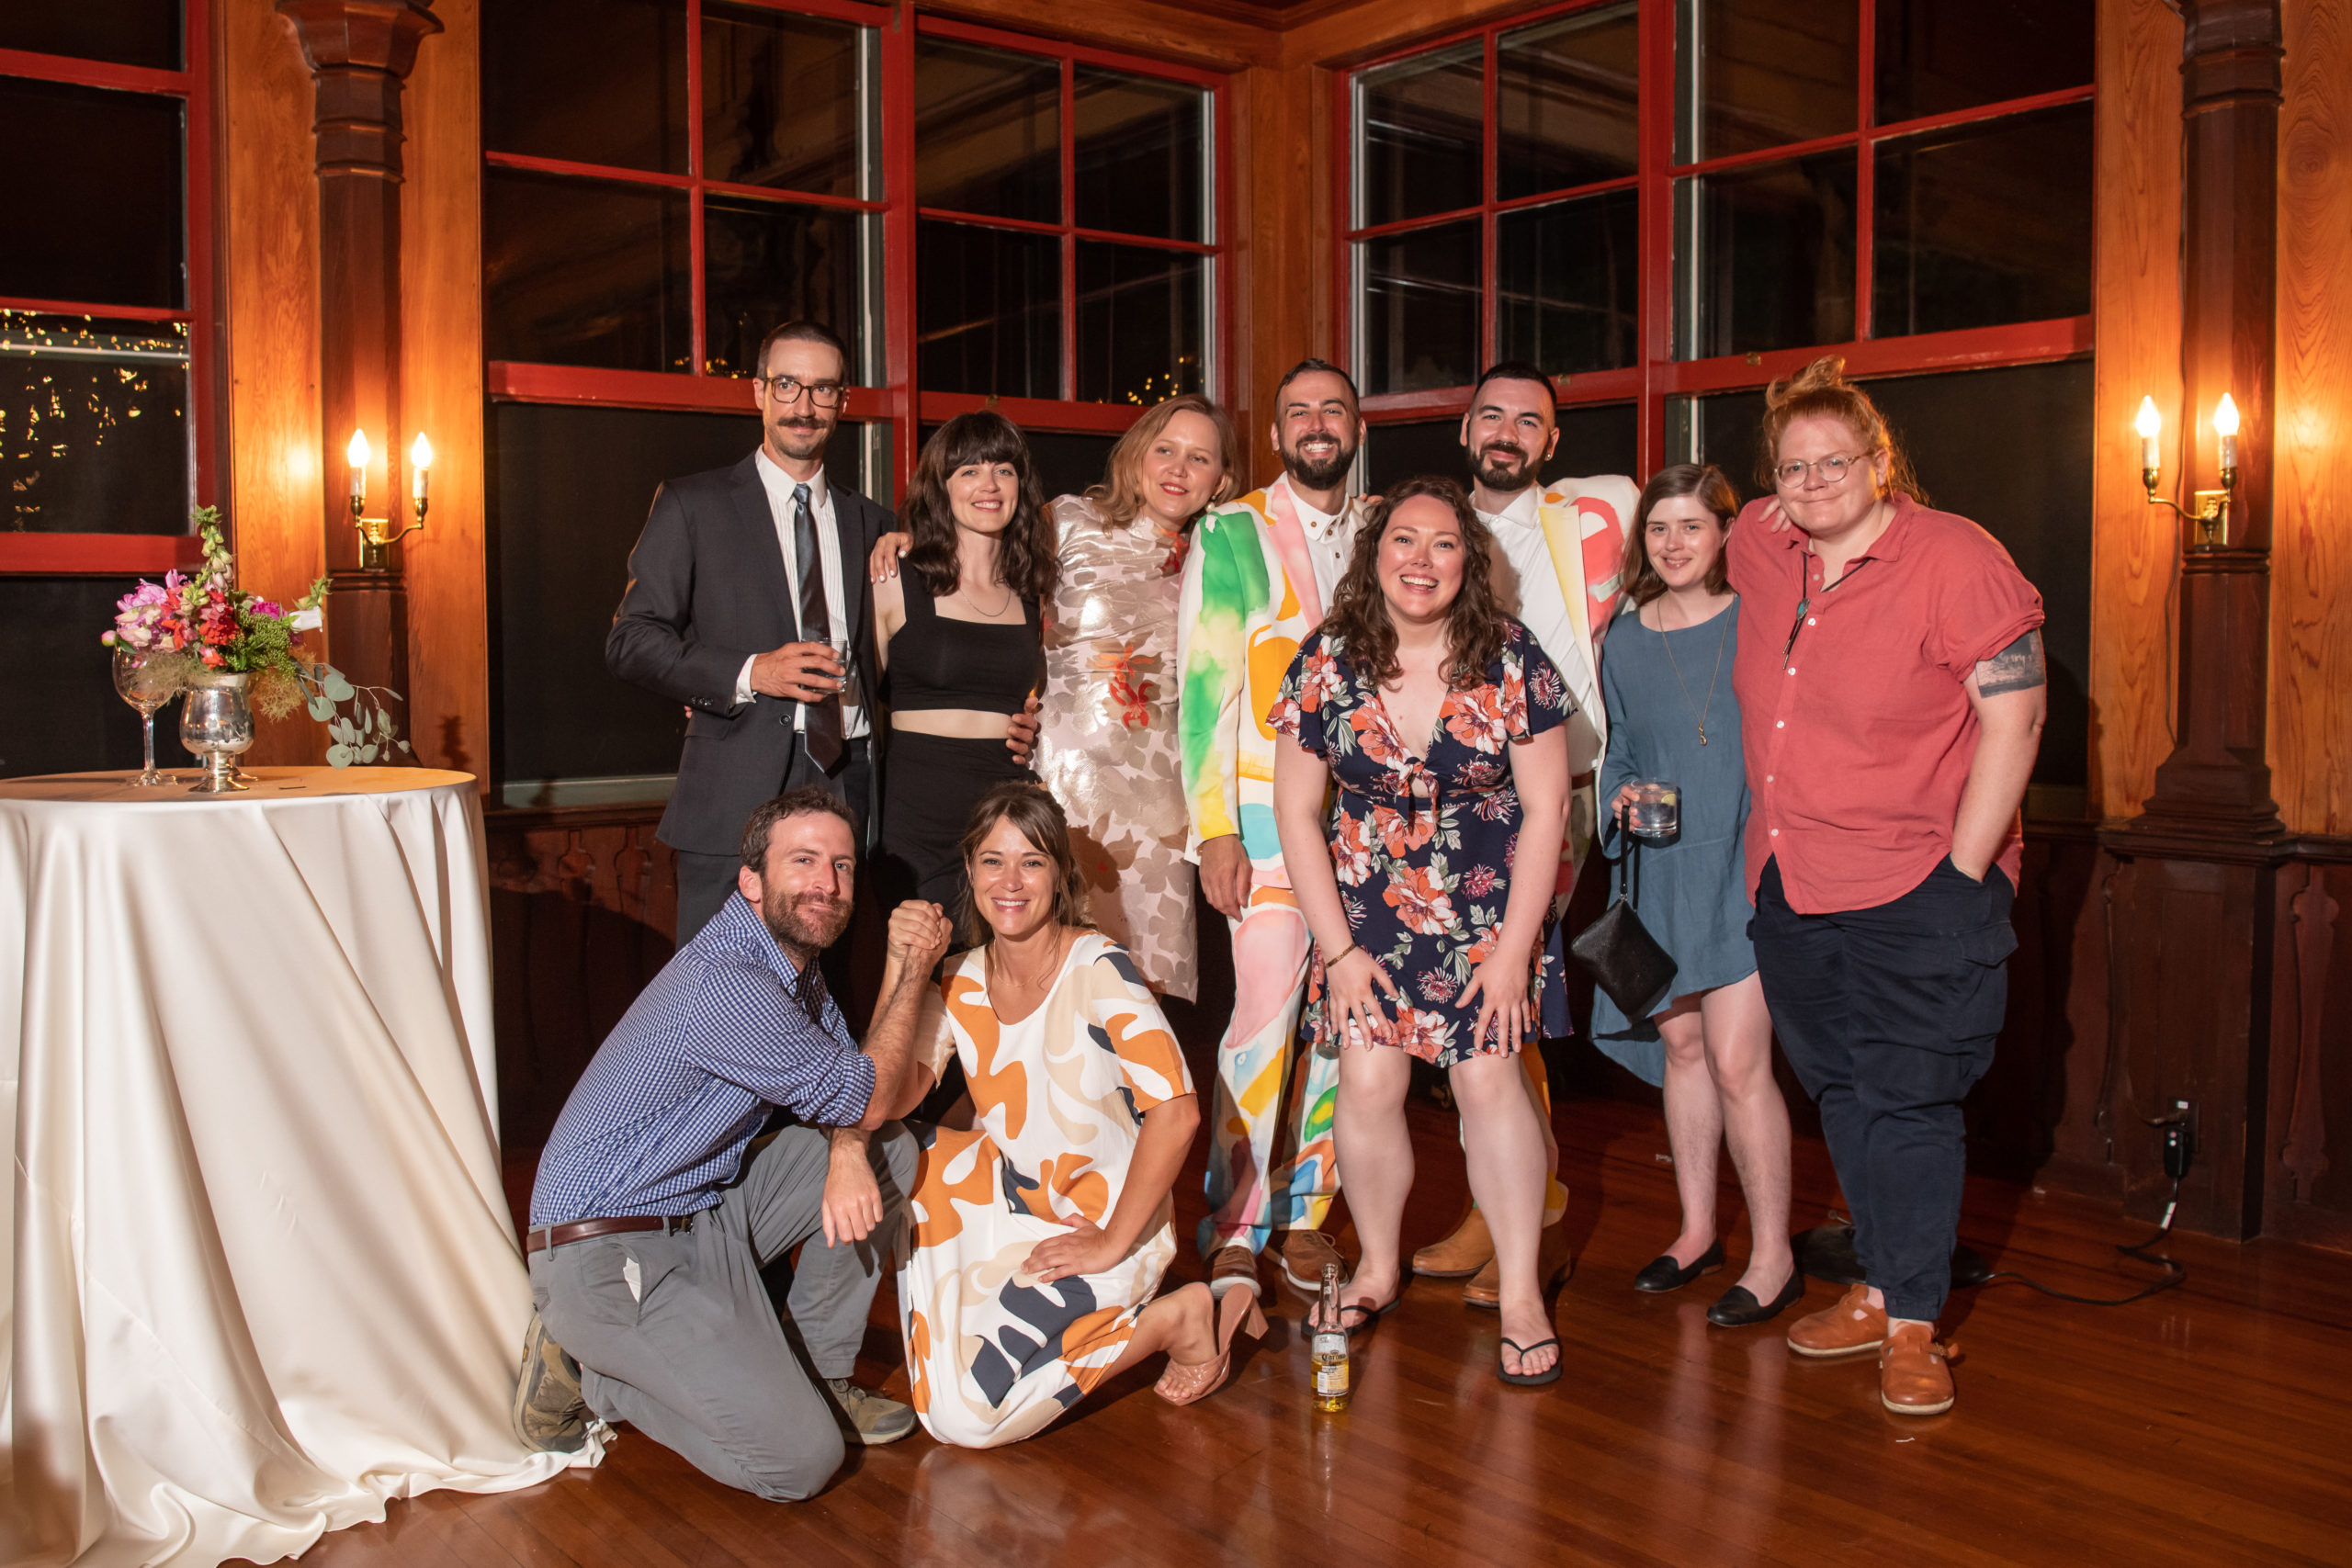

{"left": 0, "top": 0, "right": 219, "bottom": 576}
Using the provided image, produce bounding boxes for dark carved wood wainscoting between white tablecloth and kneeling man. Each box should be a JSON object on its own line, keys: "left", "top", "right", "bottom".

{"left": 482, "top": 802, "right": 677, "bottom": 1149}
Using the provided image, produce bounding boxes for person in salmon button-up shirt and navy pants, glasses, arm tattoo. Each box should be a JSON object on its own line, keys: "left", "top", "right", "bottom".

{"left": 1731, "top": 357, "right": 2046, "bottom": 1416}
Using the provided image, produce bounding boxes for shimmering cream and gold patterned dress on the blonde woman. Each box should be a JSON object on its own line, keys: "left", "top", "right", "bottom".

{"left": 1033, "top": 496, "right": 1197, "bottom": 1001}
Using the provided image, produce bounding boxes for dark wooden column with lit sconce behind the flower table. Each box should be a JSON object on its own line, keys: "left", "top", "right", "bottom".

{"left": 277, "top": 0, "right": 442, "bottom": 696}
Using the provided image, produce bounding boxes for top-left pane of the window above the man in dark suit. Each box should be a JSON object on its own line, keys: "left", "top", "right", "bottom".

{"left": 482, "top": 0, "right": 687, "bottom": 174}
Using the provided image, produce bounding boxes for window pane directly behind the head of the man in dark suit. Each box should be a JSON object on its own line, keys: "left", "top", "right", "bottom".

{"left": 703, "top": 195, "right": 873, "bottom": 381}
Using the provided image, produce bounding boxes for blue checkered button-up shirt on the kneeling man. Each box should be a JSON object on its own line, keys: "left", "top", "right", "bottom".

{"left": 532, "top": 896, "right": 875, "bottom": 1227}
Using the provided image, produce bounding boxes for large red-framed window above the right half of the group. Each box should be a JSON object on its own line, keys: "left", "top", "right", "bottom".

{"left": 1334, "top": 0, "right": 2091, "bottom": 470}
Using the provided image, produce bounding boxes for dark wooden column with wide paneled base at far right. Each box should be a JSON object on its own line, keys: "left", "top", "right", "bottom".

{"left": 2103, "top": 0, "right": 2289, "bottom": 1236}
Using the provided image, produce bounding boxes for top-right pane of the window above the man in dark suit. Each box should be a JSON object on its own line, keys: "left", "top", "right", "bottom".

{"left": 703, "top": 5, "right": 879, "bottom": 195}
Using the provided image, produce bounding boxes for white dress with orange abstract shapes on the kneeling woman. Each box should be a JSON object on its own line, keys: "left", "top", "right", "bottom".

{"left": 899, "top": 931, "right": 1193, "bottom": 1448}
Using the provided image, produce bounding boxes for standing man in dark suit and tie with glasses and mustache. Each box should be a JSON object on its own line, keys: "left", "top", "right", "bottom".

{"left": 605, "top": 322, "right": 894, "bottom": 947}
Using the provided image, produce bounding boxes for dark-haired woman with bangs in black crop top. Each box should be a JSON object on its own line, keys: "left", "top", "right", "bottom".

{"left": 875, "top": 412, "right": 1056, "bottom": 929}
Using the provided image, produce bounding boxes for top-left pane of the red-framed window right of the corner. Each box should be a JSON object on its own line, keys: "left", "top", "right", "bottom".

{"left": 1355, "top": 40, "right": 1487, "bottom": 228}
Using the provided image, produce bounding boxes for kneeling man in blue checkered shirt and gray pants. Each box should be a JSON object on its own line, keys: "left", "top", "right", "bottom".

{"left": 515, "top": 787, "right": 950, "bottom": 1500}
